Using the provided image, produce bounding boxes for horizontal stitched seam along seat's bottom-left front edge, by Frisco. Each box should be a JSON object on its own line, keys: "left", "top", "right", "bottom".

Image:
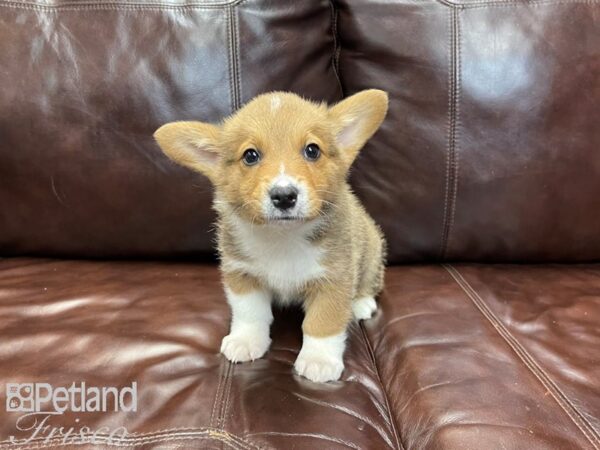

{"left": 0, "top": 427, "right": 260, "bottom": 450}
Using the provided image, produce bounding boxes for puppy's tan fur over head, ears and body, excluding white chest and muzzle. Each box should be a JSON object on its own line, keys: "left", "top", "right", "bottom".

{"left": 155, "top": 90, "right": 387, "bottom": 378}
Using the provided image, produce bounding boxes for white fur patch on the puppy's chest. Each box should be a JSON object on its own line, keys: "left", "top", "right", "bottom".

{"left": 224, "top": 216, "right": 325, "bottom": 302}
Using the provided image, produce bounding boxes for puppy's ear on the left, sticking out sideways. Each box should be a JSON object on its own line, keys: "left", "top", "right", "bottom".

{"left": 154, "top": 122, "right": 219, "bottom": 181}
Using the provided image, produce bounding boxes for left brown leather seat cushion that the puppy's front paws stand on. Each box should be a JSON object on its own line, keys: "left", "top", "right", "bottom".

{"left": 0, "top": 258, "right": 399, "bottom": 449}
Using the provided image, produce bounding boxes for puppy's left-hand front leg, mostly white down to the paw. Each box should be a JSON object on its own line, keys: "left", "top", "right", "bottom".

{"left": 221, "top": 272, "right": 273, "bottom": 363}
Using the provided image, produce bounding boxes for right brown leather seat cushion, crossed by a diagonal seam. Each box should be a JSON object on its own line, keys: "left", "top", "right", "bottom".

{"left": 365, "top": 265, "right": 600, "bottom": 449}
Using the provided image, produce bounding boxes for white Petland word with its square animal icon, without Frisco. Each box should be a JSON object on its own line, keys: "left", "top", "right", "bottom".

{"left": 6, "top": 381, "right": 137, "bottom": 414}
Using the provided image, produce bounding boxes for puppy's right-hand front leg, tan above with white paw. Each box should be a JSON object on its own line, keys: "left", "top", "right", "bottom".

{"left": 294, "top": 283, "right": 352, "bottom": 382}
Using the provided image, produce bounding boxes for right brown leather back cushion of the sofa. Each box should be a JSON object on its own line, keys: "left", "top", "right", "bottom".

{"left": 337, "top": 0, "right": 600, "bottom": 262}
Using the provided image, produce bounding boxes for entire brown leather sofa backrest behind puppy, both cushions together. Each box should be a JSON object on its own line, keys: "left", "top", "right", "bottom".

{"left": 0, "top": 0, "right": 600, "bottom": 263}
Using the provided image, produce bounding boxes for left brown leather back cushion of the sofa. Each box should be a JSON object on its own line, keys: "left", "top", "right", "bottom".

{"left": 0, "top": 0, "right": 341, "bottom": 257}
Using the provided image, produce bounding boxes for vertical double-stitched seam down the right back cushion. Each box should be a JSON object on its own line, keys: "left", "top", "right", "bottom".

{"left": 440, "top": 9, "right": 461, "bottom": 259}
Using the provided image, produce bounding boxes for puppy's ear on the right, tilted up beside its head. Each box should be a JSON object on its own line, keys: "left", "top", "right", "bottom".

{"left": 329, "top": 89, "right": 388, "bottom": 164}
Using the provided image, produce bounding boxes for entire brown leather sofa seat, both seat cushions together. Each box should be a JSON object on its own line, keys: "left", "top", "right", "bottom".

{"left": 0, "top": 258, "right": 600, "bottom": 449}
